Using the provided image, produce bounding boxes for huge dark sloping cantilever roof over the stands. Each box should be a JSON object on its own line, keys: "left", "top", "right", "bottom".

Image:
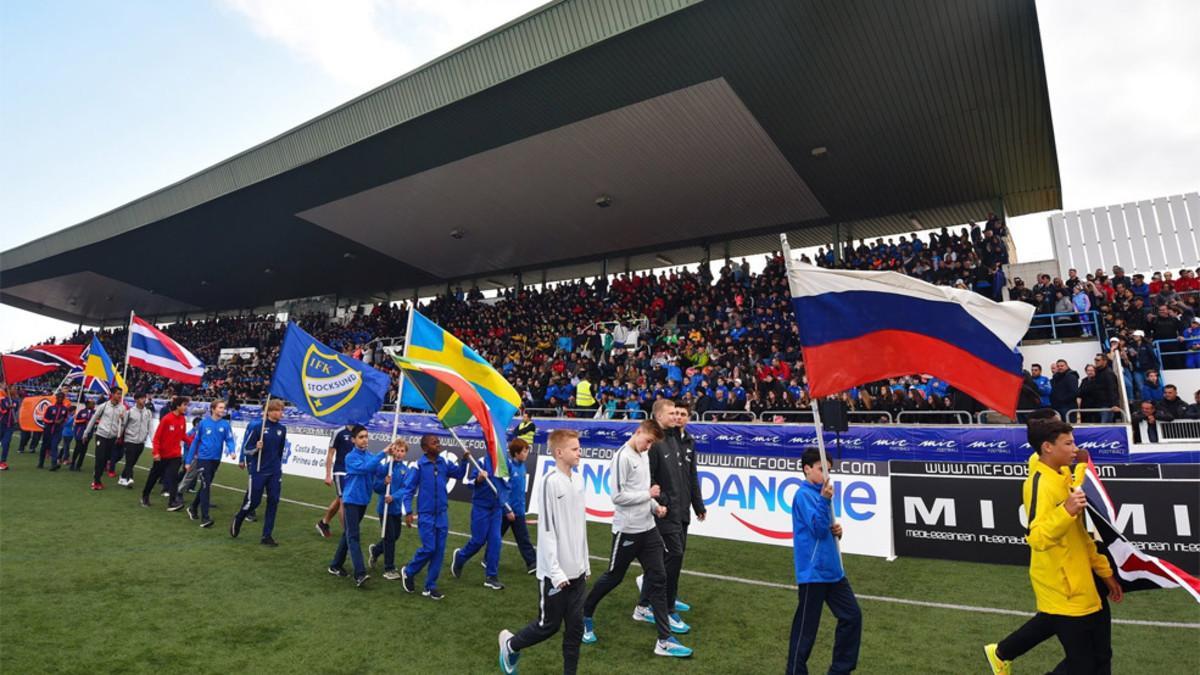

{"left": 0, "top": 0, "right": 1061, "bottom": 323}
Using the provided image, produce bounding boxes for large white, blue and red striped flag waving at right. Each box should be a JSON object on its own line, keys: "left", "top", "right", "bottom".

{"left": 785, "top": 239, "right": 1033, "bottom": 417}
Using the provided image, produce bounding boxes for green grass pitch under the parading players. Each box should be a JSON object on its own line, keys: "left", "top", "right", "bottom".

{"left": 0, "top": 441, "right": 1200, "bottom": 674}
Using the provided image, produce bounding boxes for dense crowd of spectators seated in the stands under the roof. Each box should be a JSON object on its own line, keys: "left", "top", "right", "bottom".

{"left": 11, "top": 215, "right": 1200, "bottom": 423}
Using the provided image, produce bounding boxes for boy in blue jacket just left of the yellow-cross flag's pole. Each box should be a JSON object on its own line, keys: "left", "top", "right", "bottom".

{"left": 329, "top": 424, "right": 391, "bottom": 587}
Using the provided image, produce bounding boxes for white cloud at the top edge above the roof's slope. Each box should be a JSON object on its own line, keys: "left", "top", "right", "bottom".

{"left": 222, "top": 0, "right": 541, "bottom": 91}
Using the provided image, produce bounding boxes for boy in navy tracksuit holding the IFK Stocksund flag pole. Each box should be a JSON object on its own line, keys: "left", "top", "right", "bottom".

{"left": 229, "top": 399, "right": 288, "bottom": 548}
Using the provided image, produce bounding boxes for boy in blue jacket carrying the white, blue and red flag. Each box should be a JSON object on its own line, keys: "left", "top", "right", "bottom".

{"left": 787, "top": 448, "right": 863, "bottom": 675}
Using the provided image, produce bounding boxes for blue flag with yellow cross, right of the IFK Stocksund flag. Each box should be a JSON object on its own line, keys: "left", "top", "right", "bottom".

{"left": 403, "top": 310, "right": 521, "bottom": 471}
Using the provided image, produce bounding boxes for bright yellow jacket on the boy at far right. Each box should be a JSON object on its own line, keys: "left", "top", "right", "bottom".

{"left": 1022, "top": 454, "right": 1112, "bottom": 616}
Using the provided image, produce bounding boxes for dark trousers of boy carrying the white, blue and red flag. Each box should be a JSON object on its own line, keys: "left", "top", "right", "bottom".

{"left": 787, "top": 577, "right": 863, "bottom": 675}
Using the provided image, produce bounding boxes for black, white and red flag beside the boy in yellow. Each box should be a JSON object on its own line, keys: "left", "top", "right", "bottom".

{"left": 1075, "top": 458, "right": 1200, "bottom": 602}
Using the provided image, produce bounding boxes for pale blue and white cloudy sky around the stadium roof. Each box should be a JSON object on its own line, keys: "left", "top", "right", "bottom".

{"left": 0, "top": 0, "right": 1200, "bottom": 351}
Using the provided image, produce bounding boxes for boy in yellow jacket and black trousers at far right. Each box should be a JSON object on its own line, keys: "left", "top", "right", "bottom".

{"left": 988, "top": 420, "right": 1122, "bottom": 675}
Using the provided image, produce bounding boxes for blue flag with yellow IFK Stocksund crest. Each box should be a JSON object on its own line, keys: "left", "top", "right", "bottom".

{"left": 271, "top": 321, "right": 391, "bottom": 424}
